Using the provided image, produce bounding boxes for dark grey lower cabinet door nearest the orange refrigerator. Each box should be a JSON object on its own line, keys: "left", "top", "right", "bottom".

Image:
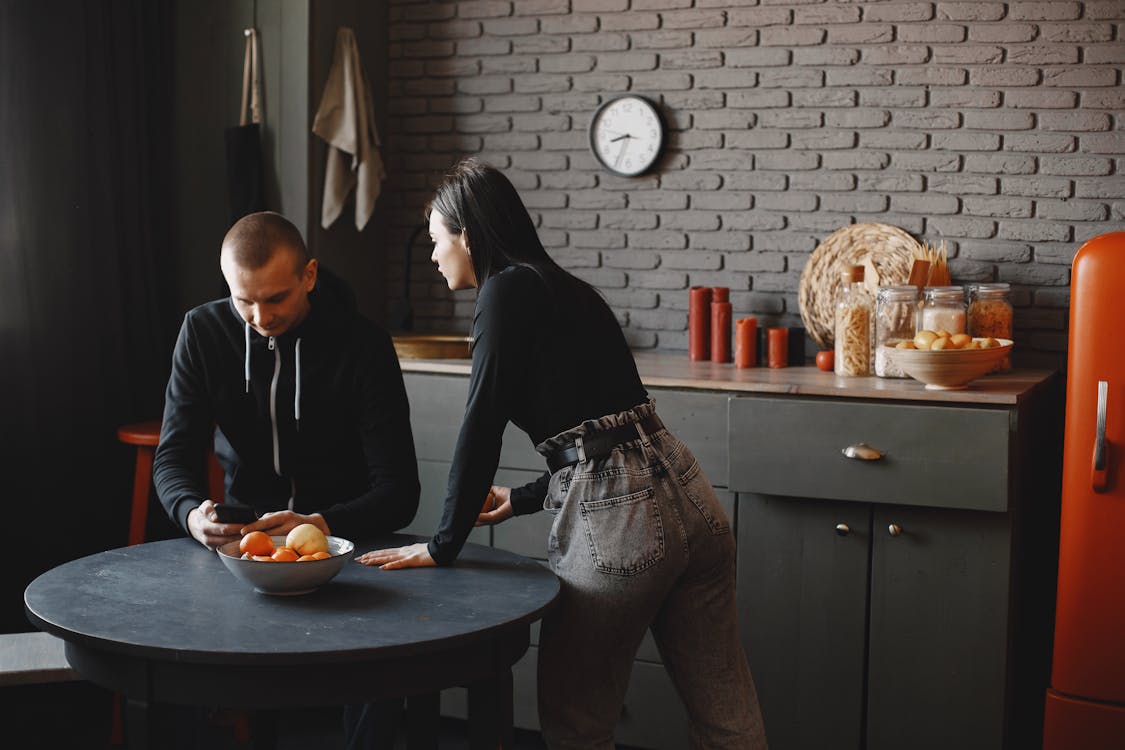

{"left": 867, "top": 507, "right": 1010, "bottom": 750}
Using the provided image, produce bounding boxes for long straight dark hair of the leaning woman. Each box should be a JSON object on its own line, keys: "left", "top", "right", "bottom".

{"left": 425, "top": 159, "right": 596, "bottom": 293}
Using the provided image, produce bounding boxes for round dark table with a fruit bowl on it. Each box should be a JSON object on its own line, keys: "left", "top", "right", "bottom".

{"left": 24, "top": 534, "right": 559, "bottom": 750}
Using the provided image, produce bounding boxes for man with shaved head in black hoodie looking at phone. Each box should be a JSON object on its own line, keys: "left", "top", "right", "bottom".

{"left": 153, "top": 211, "right": 420, "bottom": 748}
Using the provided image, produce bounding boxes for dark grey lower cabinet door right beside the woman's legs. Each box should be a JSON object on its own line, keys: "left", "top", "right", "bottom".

{"left": 738, "top": 493, "right": 868, "bottom": 750}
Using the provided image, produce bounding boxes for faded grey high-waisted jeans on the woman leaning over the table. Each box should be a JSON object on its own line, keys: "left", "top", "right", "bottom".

{"left": 537, "top": 401, "right": 766, "bottom": 750}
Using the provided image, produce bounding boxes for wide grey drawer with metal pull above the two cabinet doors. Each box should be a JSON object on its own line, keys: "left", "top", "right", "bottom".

{"left": 729, "top": 397, "right": 1011, "bottom": 512}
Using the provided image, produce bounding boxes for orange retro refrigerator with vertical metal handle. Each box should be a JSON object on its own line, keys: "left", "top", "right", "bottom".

{"left": 1043, "top": 232, "right": 1125, "bottom": 750}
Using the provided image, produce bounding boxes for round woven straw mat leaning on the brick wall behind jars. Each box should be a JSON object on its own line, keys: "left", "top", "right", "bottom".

{"left": 798, "top": 222, "right": 921, "bottom": 349}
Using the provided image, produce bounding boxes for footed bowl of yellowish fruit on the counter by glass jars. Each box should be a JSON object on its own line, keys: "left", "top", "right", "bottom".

{"left": 885, "top": 331, "right": 1013, "bottom": 390}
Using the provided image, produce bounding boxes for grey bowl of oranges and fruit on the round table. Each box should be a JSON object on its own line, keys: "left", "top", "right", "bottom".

{"left": 218, "top": 524, "right": 356, "bottom": 595}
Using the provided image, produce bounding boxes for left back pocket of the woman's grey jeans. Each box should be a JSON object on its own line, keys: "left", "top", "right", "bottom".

{"left": 579, "top": 487, "right": 664, "bottom": 576}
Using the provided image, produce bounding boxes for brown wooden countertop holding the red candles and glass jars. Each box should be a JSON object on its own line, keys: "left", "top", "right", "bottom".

{"left": 401, "top": 351, "right": 1055, "bottom": 406}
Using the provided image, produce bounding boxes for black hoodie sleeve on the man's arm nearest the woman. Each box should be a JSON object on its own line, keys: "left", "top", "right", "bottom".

{"left": 323, "top": 329, "right": 421, "bottom": 539}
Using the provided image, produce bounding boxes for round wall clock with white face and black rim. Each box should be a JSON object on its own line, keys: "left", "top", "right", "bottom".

{"left": 590, "top": 96, "right": 664, "bottom": 177}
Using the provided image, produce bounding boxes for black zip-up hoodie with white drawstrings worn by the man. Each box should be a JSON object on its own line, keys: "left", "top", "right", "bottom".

{"left": 153, "top": 266, "right": 420, "bottom": 540}
